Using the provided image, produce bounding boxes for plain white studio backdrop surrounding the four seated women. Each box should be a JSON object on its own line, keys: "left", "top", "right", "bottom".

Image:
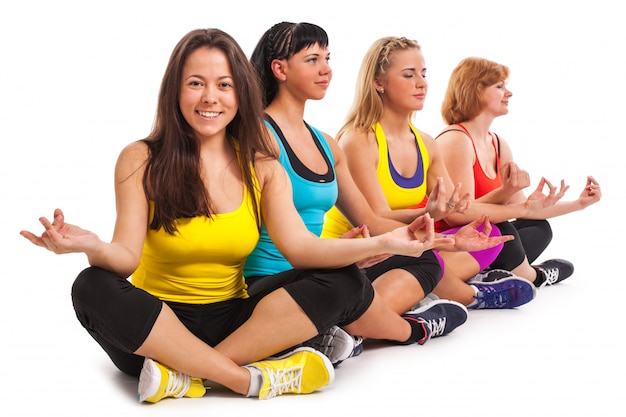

{"left": 0, "top": 0, "right": 626, "bottom": 416}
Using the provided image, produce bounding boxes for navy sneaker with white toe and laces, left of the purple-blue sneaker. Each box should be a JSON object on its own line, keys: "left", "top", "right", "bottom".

{"left": 402, "top": 299, "right": 467, "bottom": 345}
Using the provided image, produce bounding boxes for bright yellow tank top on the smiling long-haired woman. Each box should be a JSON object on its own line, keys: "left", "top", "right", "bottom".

{"left": 132, "top": 173, "right": 260, "bottom": 304}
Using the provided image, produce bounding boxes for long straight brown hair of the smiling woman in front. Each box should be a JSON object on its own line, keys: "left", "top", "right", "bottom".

{"left": 143, "top": 29, "right": 273, "bottom": 233}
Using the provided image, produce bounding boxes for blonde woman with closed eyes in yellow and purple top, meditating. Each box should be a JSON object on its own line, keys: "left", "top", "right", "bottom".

{"left": 322, "top": 37, "right": 559, "bottom": 309}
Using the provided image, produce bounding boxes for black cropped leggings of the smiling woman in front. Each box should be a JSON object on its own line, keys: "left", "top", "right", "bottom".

{"left": 72, "top": 265, "right": 374, "bottom": 376}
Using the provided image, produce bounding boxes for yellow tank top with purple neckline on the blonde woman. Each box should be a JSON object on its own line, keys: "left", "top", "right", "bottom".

{"left": 322, "top": 123, "right": 430, "bottom": 238}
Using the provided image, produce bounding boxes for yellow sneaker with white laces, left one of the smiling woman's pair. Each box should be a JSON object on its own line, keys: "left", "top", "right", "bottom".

{"left": 139, "top": 358, "right": 206, "bottom": 403}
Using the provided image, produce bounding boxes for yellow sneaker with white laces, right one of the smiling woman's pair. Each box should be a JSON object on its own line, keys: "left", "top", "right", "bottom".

{"left": 249, "top": 347, "right": 335, "bottom": 400}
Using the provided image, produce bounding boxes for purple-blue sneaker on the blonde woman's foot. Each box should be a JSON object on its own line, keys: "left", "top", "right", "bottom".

{"left": 469, "top": 276, "right": 537, "bottom": 309}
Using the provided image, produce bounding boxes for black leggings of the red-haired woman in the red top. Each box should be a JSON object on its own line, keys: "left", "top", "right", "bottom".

{"left": 490, "top": 220, "right": 552, "bottom": 271}
